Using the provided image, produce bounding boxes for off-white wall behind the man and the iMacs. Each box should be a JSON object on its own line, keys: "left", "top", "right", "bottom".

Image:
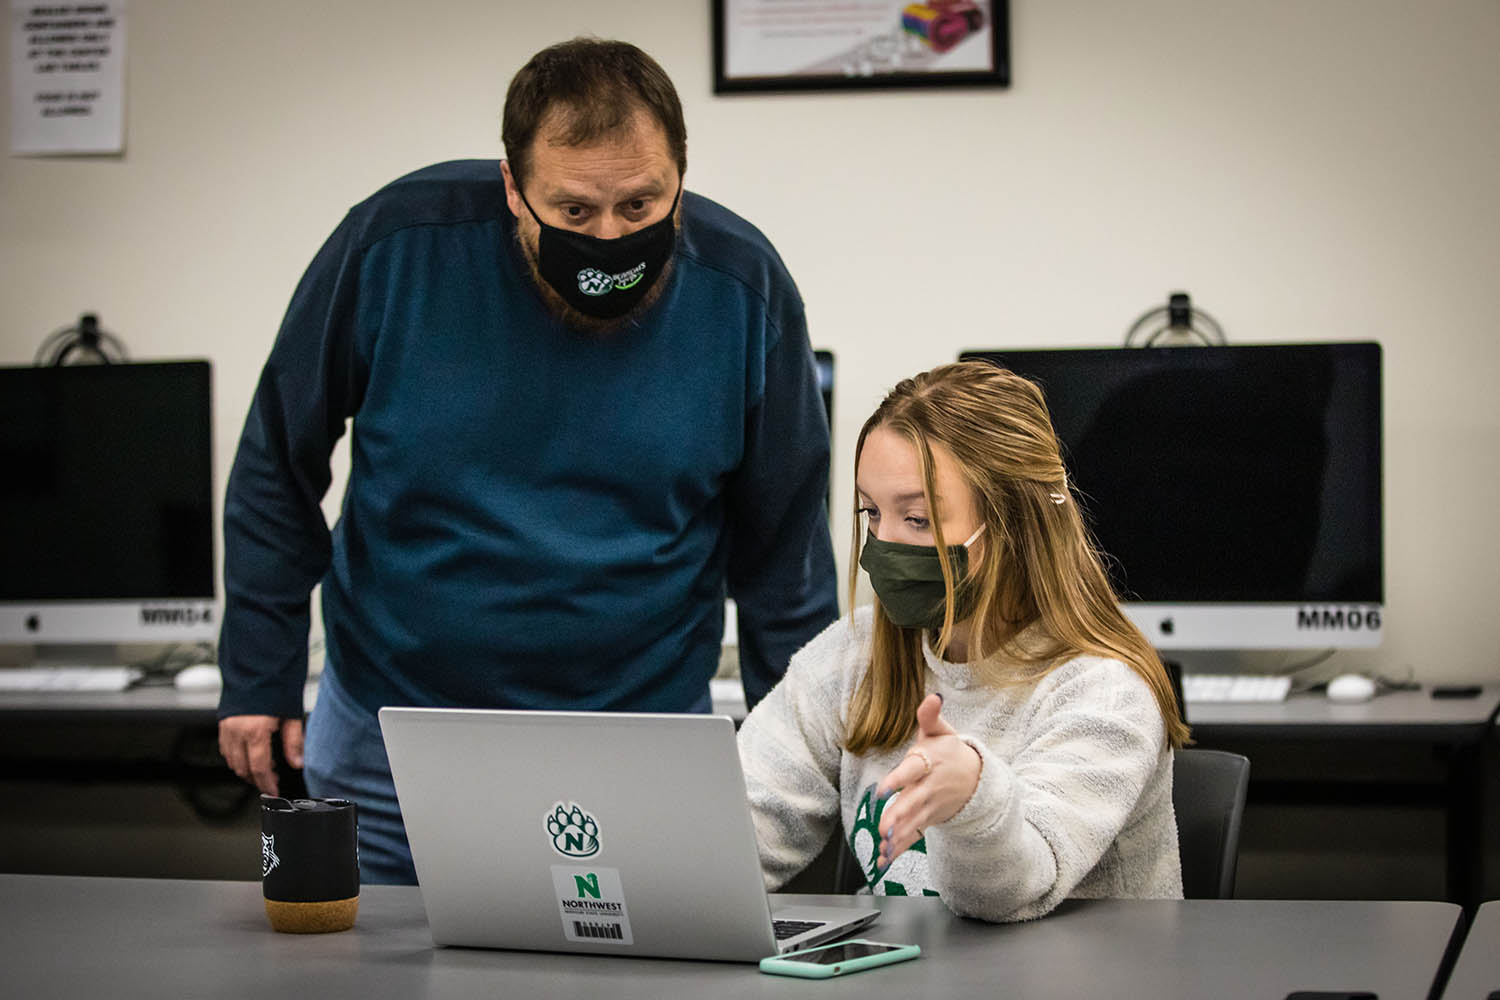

{"left": 0, "top": 0, "right": 1500, "bottom": 681}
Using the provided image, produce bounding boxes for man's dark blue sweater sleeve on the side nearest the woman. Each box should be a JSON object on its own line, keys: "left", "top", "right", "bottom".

{"left": 728, "top": 299, "right": 839, "bottom": 708}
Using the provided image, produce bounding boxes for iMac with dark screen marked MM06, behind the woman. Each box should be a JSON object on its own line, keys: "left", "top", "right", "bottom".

{"left": 960, "top": 342, "right": 1385, "bottom": 649}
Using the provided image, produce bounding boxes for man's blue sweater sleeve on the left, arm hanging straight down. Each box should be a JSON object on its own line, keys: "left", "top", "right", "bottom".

{"left": 219, "top": 217, "right": 363, "bottom": 718}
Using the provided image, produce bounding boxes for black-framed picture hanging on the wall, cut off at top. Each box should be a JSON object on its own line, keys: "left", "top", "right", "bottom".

{"left": 713, "top": 0, "right": 1011, "bottom": 94}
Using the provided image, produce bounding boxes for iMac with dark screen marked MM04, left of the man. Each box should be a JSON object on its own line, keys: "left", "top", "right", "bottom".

{"left": 0, "top": 361, "right": 218, "bottom": 648}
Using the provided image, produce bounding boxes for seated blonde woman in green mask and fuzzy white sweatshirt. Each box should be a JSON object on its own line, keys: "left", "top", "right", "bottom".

{"left": 740, "top": 363, "right": 1188, "bottom": 921}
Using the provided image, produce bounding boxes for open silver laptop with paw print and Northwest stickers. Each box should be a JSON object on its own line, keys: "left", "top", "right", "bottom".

{"left": 380, "top": 708, "right": 878, "bottom": 961}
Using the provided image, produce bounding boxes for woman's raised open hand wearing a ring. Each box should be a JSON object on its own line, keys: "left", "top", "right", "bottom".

{"left": 876, "top": 694, "right": 983, "bottom": 871}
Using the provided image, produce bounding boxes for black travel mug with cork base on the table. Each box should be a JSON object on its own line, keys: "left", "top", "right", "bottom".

{"left": 261, "top": 795, "right": 360, "bottom": 934}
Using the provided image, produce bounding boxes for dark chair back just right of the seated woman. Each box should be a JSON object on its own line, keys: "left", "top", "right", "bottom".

{"left": 1172, "top": 750, "right": 1250, "bottom": 900}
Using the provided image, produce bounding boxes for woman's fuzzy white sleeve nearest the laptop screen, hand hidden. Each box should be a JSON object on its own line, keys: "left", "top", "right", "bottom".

{"left": 740, "top": 622, "right": 849, "bottom": 891}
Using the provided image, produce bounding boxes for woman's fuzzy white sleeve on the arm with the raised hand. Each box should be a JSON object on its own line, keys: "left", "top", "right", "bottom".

{"left": 927, "top": 658, "right": 1166, "bottom": 921}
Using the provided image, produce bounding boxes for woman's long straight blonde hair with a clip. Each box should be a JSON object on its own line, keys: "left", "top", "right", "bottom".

{"left": 845, "top": 361, "right": 1188, "bottom": 754}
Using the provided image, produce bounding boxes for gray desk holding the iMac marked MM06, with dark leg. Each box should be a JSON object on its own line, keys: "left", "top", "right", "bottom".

{"left": 1187, "top": 685, "right": 1500, "bottom": 912}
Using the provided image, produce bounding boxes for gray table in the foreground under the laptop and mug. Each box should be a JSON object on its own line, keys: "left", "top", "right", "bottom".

{"left": 0, "top": 876, "right": 1460, "bottom": 1000}
